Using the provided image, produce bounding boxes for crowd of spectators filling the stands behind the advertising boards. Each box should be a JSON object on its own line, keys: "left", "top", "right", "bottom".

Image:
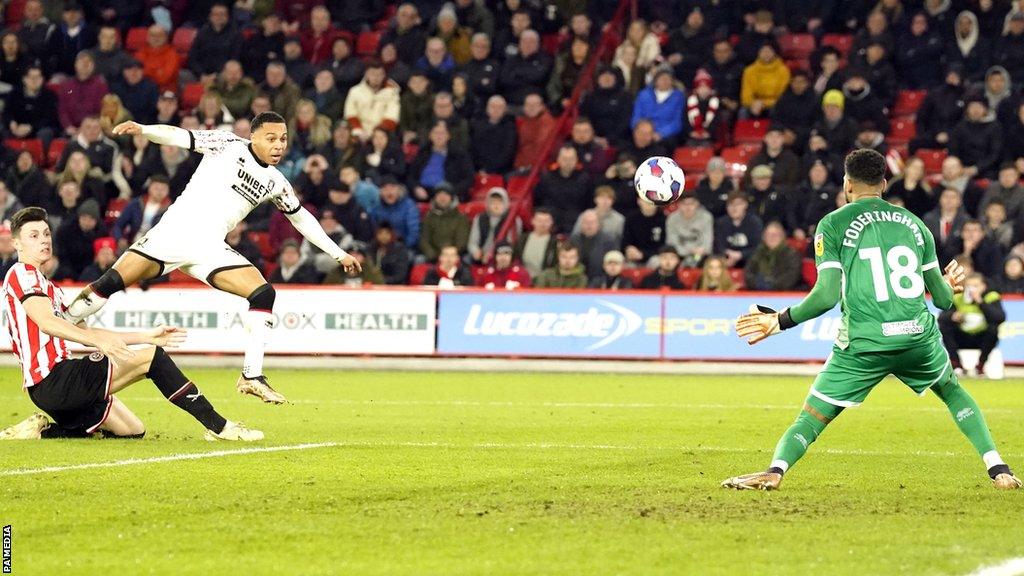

{"left": 0, "top": 0, "right": 1024, "bottom": 293}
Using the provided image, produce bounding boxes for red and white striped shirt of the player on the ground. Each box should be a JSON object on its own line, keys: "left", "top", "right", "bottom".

{"left": 3, "top": 262, "right": 71, "bottom": 388}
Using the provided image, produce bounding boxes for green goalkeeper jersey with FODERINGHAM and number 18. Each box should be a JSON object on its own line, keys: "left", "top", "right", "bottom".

{"left": 814, "top": 198, "right": 939, "bottom": 352}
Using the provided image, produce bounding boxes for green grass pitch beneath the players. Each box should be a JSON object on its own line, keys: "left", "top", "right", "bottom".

{"left": 0, "top": 370, "right": 1024, "bottom": 575}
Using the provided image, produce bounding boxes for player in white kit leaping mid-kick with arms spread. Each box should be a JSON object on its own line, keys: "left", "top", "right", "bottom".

{"left": 68, "top": 112, "right": 361, "bottom": 404}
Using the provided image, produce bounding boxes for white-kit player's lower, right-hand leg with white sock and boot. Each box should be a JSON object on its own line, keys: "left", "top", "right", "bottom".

{"left": 202, "top": 260, "right": 285, "bottom": 404}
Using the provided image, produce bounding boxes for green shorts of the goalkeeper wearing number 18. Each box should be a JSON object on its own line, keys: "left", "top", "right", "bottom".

{"left": 811, "top": 338, "right": 952, "bottom": 408}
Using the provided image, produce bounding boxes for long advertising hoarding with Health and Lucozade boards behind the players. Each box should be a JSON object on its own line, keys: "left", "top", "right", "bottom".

{"left": 0, "top": 286, "right": 1024, "bottom": 365}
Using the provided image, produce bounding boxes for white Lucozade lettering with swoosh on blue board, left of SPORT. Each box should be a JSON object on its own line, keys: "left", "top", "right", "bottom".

{"left": 462, "top": 300, "right": 643, "bottom": 351}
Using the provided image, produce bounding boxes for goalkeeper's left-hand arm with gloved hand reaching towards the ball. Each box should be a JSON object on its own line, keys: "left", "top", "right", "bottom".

{"left": 736, "top": 268, "right": 843, "bottom": 345}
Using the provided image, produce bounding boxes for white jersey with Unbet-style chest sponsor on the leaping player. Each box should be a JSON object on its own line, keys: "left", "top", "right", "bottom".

{"left": 154, "top": 130, "right": 301, "bottom": 242}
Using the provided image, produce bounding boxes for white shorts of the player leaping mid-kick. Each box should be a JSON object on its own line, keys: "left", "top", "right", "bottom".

{"left": 128, "top": 225, "right": 253, "bottom": 287}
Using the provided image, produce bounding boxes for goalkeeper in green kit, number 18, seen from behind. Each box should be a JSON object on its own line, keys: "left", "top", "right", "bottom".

{"left": 722, "top": 150, "right": 1021, "bottom": 490}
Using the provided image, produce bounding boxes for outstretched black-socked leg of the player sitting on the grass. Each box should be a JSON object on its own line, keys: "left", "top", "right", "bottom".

{"left": 110, "top": 346, "right": 263, "bottom": 441}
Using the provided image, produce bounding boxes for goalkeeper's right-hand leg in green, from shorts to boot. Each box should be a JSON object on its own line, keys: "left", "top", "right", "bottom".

{"left": 894, "top": 339, "right": 1021, "bottom": 488}
